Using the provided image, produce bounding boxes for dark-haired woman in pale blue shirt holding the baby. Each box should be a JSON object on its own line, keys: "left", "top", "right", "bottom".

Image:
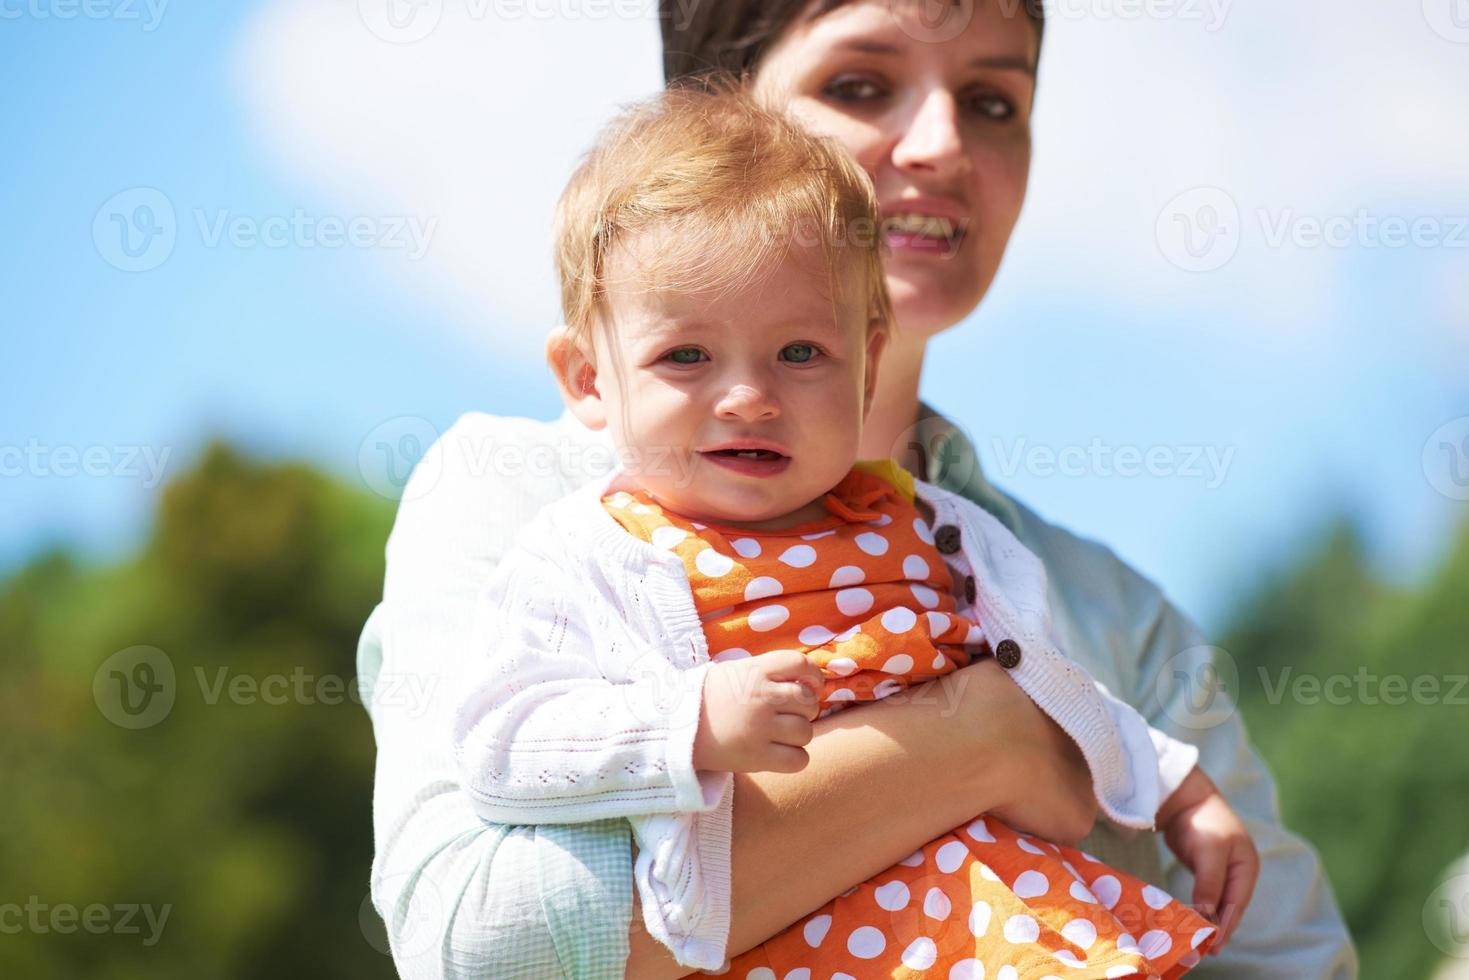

{"left": 360, "top": 0, "right": 1354, "bottom": 979}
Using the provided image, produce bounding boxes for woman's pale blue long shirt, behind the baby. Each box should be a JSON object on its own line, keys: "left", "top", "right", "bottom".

{"left": 357, "top": 406, "right": 1357, "bottom": 980}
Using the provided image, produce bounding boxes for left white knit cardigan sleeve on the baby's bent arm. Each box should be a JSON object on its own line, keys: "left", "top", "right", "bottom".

{"left": 452, "top": 537, "right": 730, "bottom": 824}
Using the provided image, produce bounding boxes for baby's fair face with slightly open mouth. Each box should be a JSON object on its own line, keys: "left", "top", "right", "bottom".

{"left": 595, "top": 237, "right": 883, "bottom": 530}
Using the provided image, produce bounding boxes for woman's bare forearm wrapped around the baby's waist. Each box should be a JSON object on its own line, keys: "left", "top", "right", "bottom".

{"left": 626, "top": 657, "right": 1096, "bottom": 980}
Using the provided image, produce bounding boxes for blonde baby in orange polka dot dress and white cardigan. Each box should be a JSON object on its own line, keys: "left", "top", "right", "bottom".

{"left": 452, "top": 90, "right": 1253, "bottom": 980}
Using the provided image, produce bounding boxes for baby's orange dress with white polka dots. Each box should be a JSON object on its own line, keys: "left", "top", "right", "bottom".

{"left": 602, "top": 460, "right": 1215, "bottom": 980}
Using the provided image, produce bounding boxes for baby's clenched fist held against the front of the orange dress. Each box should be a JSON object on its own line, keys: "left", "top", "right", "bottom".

{"left": 693, "top": 649, "right": 823, "bottom": 773}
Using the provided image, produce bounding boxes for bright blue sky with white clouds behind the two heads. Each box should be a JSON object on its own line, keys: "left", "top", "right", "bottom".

{"left": 0, "top": 0, "right": 1469, "bottom": 623}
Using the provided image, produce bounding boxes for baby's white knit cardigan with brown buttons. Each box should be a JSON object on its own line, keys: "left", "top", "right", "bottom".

{"left": 452, "top": 470, "right": 1199, "bottom": 970}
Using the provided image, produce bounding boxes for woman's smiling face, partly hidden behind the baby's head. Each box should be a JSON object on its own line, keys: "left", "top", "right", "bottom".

{"left": 754, "top": 0, "right": 1039, "bottom": 339}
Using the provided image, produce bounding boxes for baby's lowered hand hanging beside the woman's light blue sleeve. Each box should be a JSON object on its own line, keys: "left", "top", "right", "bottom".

{"left": 1158, "top": 767, "right": 1260, "bottom": 955}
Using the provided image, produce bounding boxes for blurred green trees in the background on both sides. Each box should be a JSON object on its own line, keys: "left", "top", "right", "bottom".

{"left": 0, "top": 445, "right": 1469, "bottom": 980}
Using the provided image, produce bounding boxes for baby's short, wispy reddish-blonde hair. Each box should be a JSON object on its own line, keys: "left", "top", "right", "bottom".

{"left": 555, "top": 81, "right": 896, "bottom": 351}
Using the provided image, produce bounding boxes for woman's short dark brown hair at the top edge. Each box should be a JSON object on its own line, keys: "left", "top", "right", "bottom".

{"left": 658, "top": 0, "right": 1046, "bottom": 85}
